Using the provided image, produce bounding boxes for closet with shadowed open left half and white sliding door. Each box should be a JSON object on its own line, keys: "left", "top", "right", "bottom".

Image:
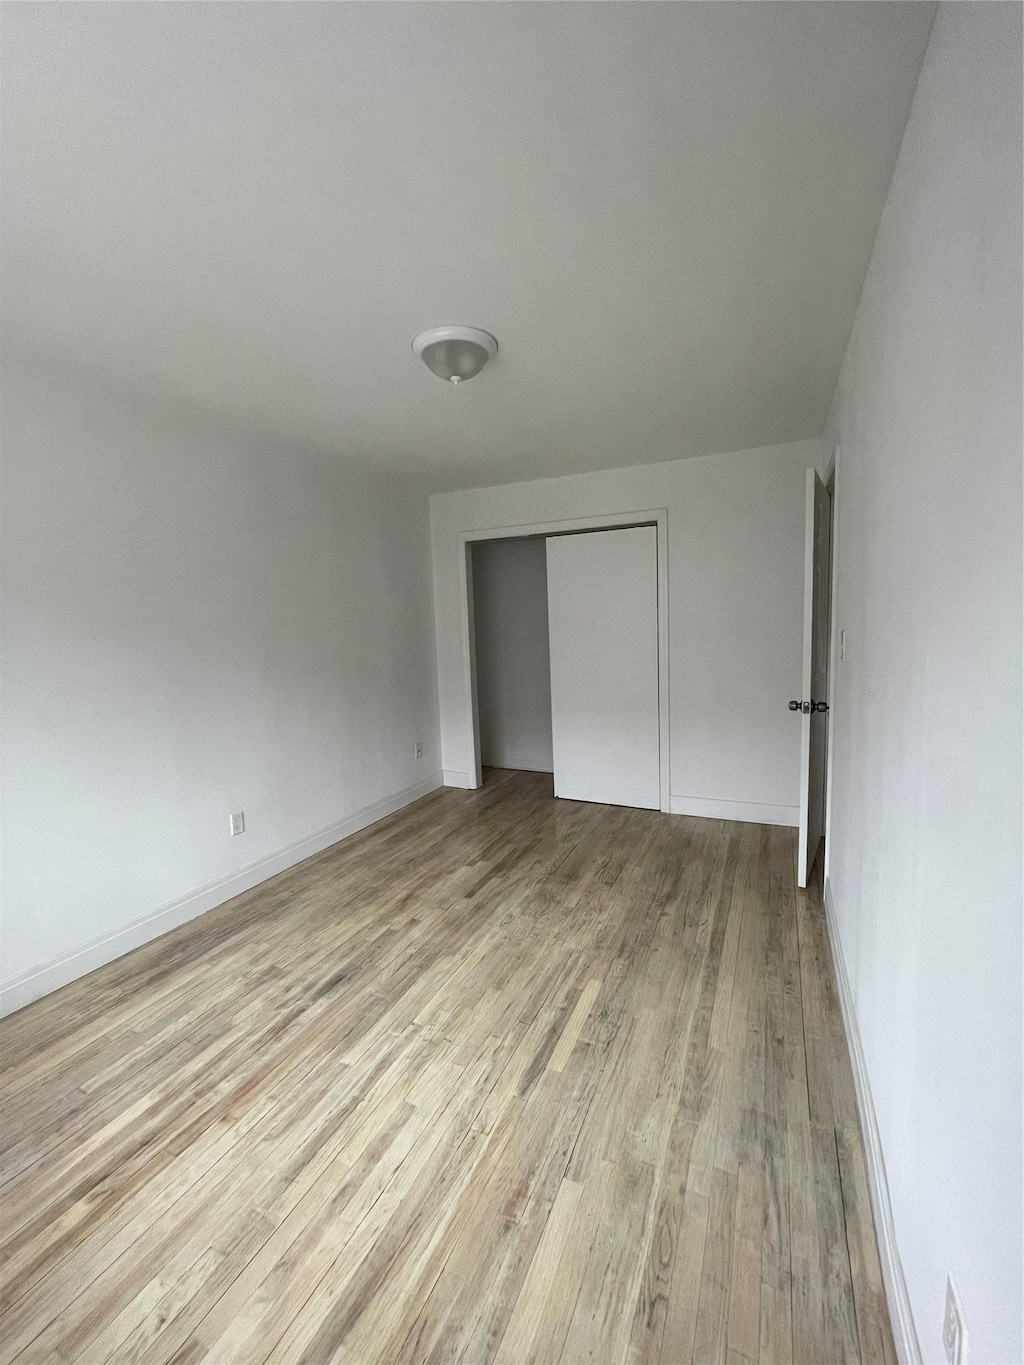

{"left": 472, "top": 526, "right": 661, "bottom": 809}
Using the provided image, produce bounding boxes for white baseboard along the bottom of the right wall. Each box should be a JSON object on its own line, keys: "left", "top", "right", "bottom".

{"left": 825, "top": 880, "right": 923, "bottom": 1365}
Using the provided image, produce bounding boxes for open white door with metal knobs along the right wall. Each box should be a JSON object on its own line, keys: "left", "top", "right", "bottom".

{"left": 789, "top": 470, "right": 831, "bottom": 886}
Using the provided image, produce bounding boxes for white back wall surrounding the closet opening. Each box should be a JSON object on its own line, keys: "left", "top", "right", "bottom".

{"left": 430, "top": 441, "right": 822, "bottom": 824}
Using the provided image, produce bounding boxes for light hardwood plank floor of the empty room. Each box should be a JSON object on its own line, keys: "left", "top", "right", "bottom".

{"left": 0, "top": 773, "right": 896, "bottom": 1365}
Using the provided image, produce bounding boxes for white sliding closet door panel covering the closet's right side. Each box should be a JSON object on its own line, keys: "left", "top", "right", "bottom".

{"left": 547, "top": 526, "right": 661, "bottom": 811}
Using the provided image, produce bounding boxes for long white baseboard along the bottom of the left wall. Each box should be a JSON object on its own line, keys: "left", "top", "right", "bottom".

{"left": 0, "top": 773, "right": 441, "bottom": 1016}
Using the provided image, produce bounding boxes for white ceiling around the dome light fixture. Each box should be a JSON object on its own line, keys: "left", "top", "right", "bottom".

{"left": 3, "top": 0, "right": 934, "bottom": 489}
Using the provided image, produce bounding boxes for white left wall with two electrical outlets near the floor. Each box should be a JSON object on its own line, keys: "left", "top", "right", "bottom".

{"left": 3, "top": 362, "right": 440, "bottom": 1007}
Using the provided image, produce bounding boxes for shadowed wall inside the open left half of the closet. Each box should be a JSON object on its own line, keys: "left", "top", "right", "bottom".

{"left": 472, "top": 541, "right": 553, "bottom": 773}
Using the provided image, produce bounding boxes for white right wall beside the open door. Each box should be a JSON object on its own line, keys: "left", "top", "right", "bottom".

{"left": 826, "top": 4, "right": 1024, "bottom": 1365}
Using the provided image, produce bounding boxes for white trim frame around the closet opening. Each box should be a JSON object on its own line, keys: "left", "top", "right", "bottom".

{"left": 457, "top": 508, "right": 672, "bottom": 814}
